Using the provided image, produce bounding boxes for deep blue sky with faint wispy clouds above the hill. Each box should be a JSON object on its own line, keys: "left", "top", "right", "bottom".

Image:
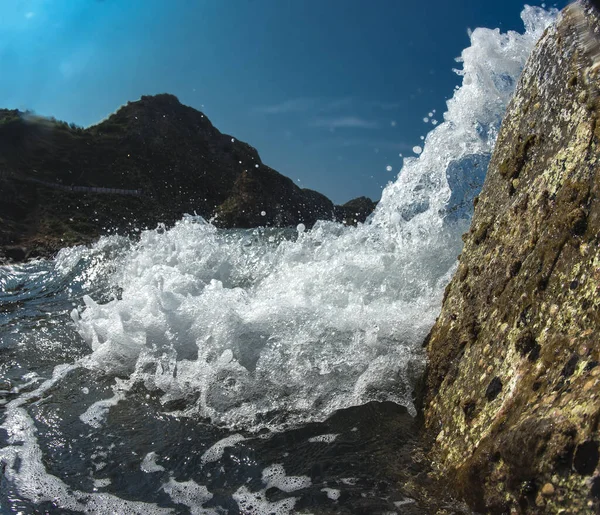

{"left": 0, "top": 0, "right": 566, "bottom": 203}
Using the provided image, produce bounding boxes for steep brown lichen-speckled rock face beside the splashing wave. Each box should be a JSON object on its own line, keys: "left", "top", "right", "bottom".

{"left": 424, "top": 5, "right": 600, "bottom": 513}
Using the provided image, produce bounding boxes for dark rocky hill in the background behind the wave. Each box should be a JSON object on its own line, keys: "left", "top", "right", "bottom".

{"left": 0, "top": 94, "right": 372, "bottom": 259}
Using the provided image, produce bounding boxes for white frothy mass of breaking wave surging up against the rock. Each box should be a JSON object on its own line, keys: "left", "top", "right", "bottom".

{"left": 62, "top": 7, "right": 554, "bottom": 436}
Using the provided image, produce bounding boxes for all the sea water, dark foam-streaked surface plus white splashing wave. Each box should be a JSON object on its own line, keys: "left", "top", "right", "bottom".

{"left": 0, "top": 7, "right": 556, "bottom": 514}
